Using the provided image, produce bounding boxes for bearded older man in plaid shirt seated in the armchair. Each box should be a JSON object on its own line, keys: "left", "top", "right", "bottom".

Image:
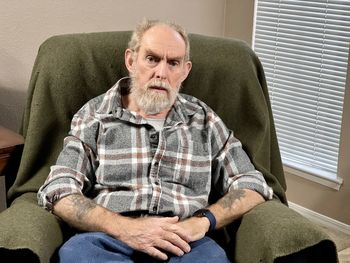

{"left": 38, "top": 20, "right": 272, "bottom": 262}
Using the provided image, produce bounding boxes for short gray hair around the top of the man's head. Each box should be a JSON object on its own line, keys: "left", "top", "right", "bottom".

{"left": 128, "top": 19, "right": 190, "bottom": 61}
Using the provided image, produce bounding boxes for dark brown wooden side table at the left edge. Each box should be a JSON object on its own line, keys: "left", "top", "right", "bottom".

{"left": 0, "top": 126, "right": 24, "bottom": 212}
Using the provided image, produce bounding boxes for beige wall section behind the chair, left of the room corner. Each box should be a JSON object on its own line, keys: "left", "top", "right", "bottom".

{"left": 0, "top": 0, "right": 226, "bottom": 130}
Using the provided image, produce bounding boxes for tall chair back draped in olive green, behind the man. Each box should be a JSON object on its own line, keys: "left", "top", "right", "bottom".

{"left": 9, "top": 31, "right": 286, "bottom": 203}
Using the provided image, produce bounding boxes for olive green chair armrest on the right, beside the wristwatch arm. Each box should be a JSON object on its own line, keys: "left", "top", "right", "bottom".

{"left": 231, "top": 201, "right": 337, "bottom": 262}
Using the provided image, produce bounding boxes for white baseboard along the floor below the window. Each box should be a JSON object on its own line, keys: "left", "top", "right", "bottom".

{"left": 288, "top": 202, "right": 350, "bottom": 235}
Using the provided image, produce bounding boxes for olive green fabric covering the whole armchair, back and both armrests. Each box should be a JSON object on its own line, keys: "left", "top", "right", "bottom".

{"left": 0, "top": 32, "right": 336, "bottom": 263}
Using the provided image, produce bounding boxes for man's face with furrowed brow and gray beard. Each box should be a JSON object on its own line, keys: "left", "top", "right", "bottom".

{"left": 126, "top": 25, "right": 191, "bottom": 114}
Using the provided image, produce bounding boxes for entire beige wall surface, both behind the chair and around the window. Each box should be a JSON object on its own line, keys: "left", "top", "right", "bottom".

{"left": 0, "top": 0, "right": 350, "bottom": 227}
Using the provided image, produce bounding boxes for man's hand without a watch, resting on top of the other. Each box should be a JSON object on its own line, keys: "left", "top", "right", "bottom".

{"left": 115, "top": 217, "right": 191, "bottom": 260}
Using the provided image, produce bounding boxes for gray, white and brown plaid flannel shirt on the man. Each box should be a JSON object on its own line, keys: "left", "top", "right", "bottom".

{"left": 38, "top": 78, "right": 272, "bottom": 218}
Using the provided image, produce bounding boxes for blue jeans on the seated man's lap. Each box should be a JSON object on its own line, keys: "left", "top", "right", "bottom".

{"left": 58, "top": 232, "right": 230, "bottom": 263}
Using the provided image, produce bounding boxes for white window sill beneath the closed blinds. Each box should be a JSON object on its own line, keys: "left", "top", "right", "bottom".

{"left": 283, "top": 165, "right": 343, "bottom": 191}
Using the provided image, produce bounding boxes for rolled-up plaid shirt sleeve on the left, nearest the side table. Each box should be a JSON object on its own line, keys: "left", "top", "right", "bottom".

{"left": 37, "top": 106, "right": 98, "bottom": 211}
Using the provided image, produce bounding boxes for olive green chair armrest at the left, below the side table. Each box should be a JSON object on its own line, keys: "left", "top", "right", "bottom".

{"left": 0, "top": 193, "right": 72, "bottom": 263}
